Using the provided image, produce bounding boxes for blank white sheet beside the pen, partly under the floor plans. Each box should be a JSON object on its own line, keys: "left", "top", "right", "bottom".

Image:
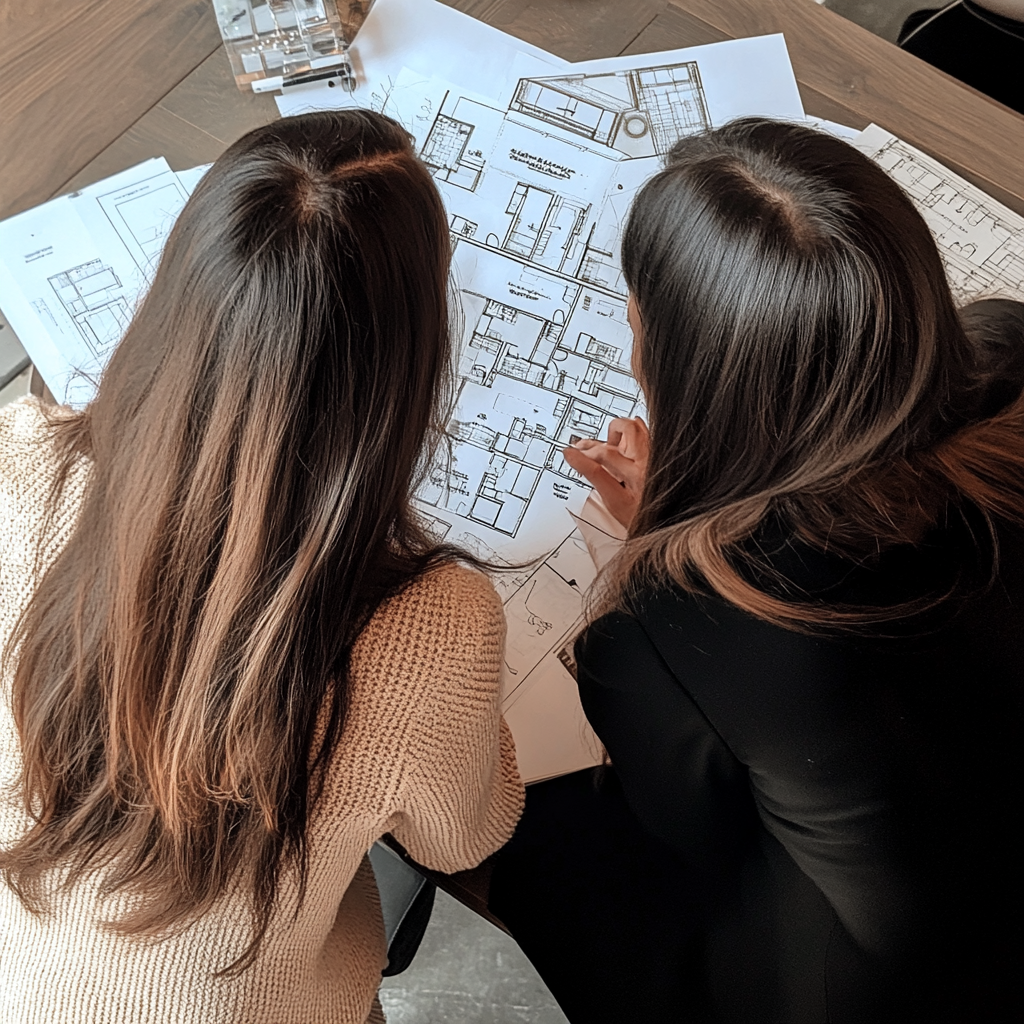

{"left": 275, "top": 0, "right": 568, "bottom": 117}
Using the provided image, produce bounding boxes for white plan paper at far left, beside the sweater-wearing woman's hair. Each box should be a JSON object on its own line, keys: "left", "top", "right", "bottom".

{"left": 0, "top": 159, "right": 205, "bottom": 406}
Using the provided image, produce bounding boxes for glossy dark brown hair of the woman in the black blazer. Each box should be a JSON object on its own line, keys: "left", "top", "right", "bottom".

{"left": 604, "top": 119, "right": 1024, "bottom": 630}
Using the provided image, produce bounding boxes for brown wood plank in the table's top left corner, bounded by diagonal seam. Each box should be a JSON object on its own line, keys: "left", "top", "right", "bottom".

{"left": 0, "top": 0, "right": 220, "bottom": 217}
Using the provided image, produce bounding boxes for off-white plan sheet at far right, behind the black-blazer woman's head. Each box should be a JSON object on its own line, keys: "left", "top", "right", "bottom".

{"left": 853, "top": 125, "right": 1024, "bottom": 305}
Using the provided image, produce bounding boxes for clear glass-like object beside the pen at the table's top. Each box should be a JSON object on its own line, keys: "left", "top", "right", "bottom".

{"left": 213, "top": 0, "right": 370, "bottom": 91}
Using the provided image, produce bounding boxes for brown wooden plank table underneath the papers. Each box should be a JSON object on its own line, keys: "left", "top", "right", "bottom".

{"left": 0, "top": 0, "right": 1024, "bottom": 912}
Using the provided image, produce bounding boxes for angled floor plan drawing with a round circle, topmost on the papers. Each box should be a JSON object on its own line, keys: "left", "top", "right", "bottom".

{"left": 509, "top": 60, "right": 711, "bottom": 159}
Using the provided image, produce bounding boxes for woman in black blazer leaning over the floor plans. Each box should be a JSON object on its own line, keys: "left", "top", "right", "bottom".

{"left": 492, "top": 120, "right": 1024, "bottom": 1024}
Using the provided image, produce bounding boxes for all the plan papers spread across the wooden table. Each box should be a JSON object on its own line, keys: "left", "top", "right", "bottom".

{"left": 0, "top": 0, "right": 1024, "bottom": 780}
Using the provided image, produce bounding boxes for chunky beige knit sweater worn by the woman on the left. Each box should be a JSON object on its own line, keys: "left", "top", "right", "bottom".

{"left": 0, "top": 399, "right": 522, "bottom": 1024}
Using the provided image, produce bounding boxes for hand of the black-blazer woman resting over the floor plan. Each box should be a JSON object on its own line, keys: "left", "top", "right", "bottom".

{"left": 562, "top": 417, "right": 650, "bottom": 529}
